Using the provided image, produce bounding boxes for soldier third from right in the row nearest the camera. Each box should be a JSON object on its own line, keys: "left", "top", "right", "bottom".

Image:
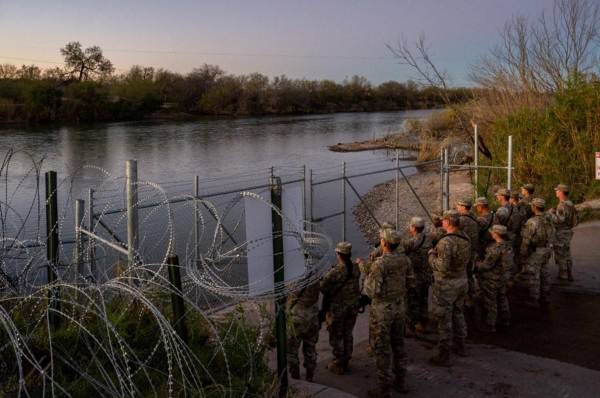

{"left": 477, "top": 225, "right": 513, "bottom": 333}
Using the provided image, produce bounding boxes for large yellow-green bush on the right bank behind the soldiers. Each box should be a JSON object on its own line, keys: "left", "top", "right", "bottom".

{"left": 486, "top": 78, "right": 600, "bottom": 204}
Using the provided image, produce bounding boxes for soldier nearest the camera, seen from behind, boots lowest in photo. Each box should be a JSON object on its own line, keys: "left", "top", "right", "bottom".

{"left": 363, "top": 229, "right": 413, "bottom": 398}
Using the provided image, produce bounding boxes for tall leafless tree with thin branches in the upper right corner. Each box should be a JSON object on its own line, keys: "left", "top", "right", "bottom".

{"left": 471, "top": 0, "right": 600, "bottom": 93}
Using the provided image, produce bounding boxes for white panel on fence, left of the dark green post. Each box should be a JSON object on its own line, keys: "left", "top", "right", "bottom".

{"left": 244, "top": 191, "right": 275, "bottom": 296}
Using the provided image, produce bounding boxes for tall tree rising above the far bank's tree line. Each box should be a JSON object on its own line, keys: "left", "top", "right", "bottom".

{"left": 60, "top": 41, "right": 115, "bottom": 81}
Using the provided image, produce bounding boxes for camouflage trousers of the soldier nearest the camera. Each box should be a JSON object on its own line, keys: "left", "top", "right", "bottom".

{"left": 369, "top": 302, "right": 407, "bottom": 386}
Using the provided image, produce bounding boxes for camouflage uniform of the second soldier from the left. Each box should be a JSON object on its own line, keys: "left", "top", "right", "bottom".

{"left": 321, "top": 262, "right": 360, "bottom": 368}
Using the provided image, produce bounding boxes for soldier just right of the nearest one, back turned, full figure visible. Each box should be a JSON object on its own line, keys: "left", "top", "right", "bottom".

{"left": 429, "top": 210, "right": 472, "bottom": 366}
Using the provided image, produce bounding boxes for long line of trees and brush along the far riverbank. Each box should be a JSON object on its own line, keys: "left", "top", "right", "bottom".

{"left": 0, "top": 42, "right": 472, "bottom": 122}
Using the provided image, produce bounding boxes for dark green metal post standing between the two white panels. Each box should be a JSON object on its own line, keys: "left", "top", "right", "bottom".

{"left": 270, "top": 177, "right": 288, "bottom": 397}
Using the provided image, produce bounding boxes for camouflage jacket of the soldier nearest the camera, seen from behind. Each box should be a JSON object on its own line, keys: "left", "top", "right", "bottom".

{"left": 363, "top": 253, "right": 414, "bottom": 304}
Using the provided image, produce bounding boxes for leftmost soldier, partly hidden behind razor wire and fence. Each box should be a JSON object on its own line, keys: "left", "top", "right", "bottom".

{"left": 287, "top": 282, "right": 321, "bottom": 381}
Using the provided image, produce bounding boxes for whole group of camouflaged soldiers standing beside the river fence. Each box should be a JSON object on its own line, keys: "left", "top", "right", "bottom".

{"left": 288, "top": 184, "right": 577, "bottom": 397}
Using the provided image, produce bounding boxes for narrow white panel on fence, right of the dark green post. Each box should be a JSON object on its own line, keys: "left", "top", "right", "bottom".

{"left": 281, "top": 182, "right": 306, "bottom": 281}
